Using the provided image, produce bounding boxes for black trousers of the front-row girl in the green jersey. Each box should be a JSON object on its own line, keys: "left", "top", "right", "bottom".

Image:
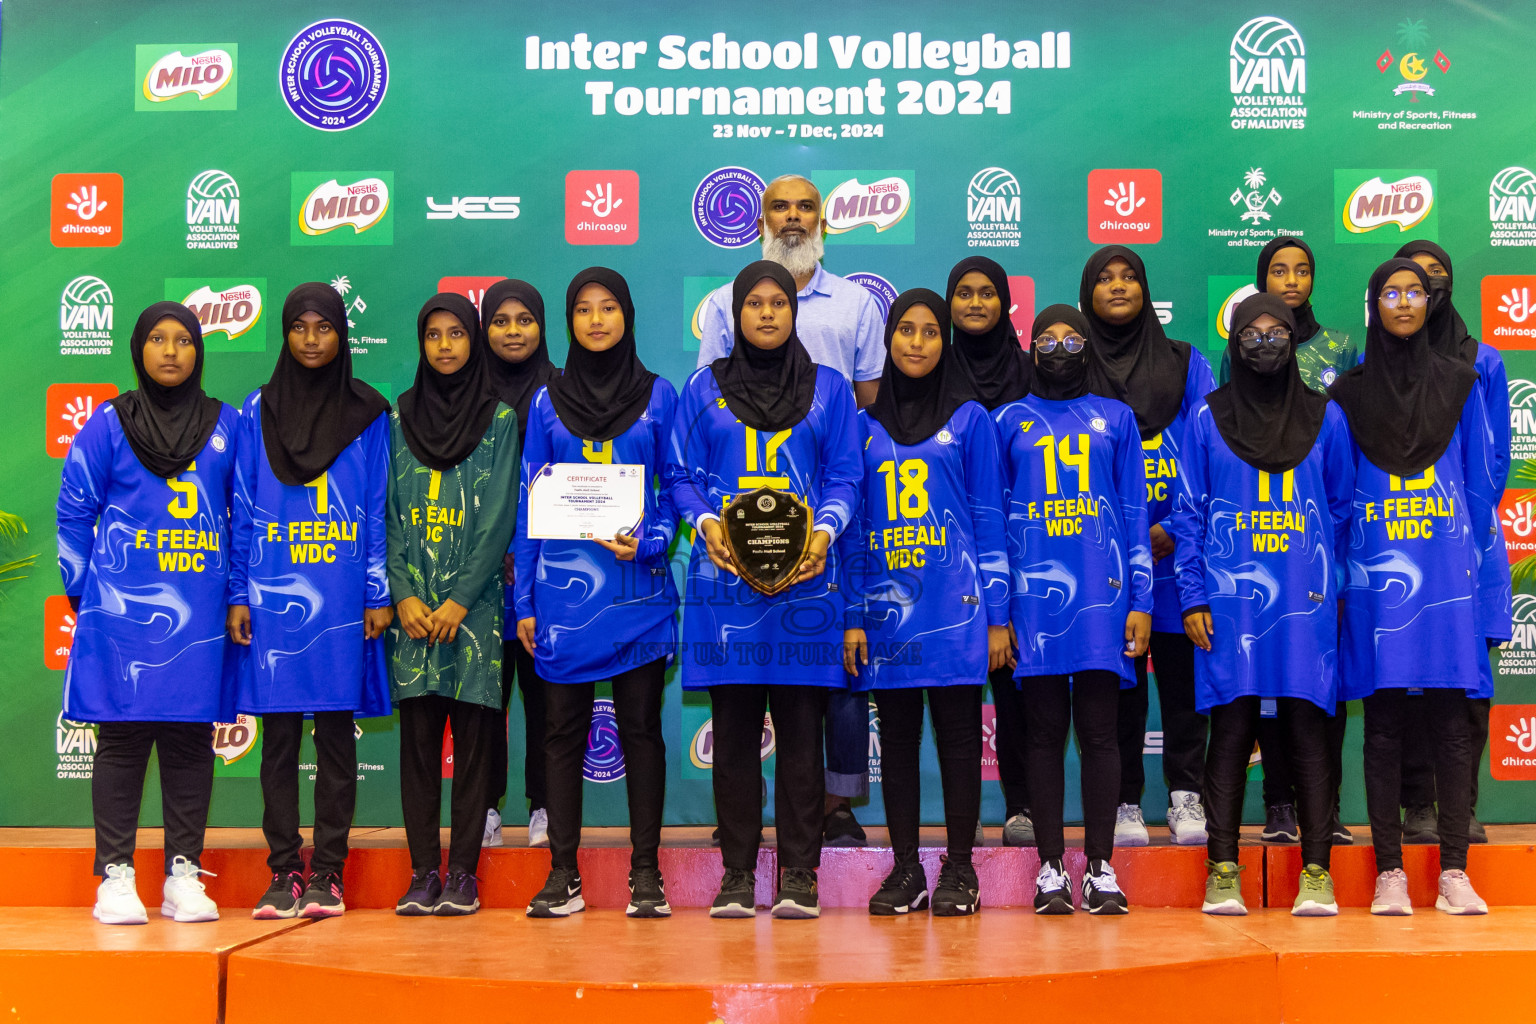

{"left": 399, "top": 694, "right": 504, "bottom": 875}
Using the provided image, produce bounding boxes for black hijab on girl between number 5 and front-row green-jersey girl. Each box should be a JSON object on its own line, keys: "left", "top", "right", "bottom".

{"left": 261, "top": 281, "right": 389, "bottom": 487}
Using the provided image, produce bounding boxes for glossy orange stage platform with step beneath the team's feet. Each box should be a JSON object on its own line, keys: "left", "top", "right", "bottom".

{"left": 0, "top": 826, "right": 1536, "bottom": 1024}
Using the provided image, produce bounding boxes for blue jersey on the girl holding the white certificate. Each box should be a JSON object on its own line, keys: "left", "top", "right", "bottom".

{"left": 513, "top": 378, "right": 677, "bottom": 683}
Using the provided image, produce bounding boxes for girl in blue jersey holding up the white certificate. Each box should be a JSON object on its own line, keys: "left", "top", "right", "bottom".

{"left": 515, "top": 267, "right": 677, "bottom": 918}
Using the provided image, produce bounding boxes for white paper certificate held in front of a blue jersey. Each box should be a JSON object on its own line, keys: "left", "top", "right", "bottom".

{"left": 528, "top": 462, "right": 647, "bottom": 540}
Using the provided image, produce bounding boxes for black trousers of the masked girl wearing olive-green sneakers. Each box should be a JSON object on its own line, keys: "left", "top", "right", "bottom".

{"left": 1203, "top": 697, "right": 1333, "bottom": 869}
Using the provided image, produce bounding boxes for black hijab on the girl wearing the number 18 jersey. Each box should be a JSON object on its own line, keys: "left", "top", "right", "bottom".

{"left": 869, "top": 289, "right": 970, "bottom": 445}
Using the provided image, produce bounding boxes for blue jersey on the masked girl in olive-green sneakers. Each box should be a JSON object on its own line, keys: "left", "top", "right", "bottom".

{"left": 1172, "top": 401, "right": 1355, "bottom": 714}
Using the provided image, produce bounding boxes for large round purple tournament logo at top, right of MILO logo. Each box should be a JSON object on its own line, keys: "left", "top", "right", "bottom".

{"left": 278, "top": 18, "right": 389, "bottom": 132}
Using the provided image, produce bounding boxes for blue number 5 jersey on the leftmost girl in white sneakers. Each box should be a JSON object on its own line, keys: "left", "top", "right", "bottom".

{"left": 58, "top": 405, "right": 240, "bottom": 722}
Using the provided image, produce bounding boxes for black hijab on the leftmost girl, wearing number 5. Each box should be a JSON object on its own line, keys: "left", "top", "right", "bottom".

{"left": 108, "top": 302, "right": 223, "bottom": 477}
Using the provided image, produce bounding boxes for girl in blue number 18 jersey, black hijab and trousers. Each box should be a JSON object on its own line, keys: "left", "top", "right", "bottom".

{"left": 839, "top": 289, "right": 1023, "bottom": 917}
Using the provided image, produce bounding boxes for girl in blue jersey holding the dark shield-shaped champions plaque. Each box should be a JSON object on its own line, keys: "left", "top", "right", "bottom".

{"left": 672, "top": 261, "right": 862, "bottom": 918}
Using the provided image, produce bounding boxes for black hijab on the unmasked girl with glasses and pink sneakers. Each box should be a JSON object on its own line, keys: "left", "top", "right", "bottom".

{"left": 1329, "top": 259, "right": 1478, "bottom": 476}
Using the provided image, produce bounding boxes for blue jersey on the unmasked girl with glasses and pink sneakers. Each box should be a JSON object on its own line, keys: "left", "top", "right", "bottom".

{"left": 1339, "top": 387, "right": 1496, "bottom": 700}
